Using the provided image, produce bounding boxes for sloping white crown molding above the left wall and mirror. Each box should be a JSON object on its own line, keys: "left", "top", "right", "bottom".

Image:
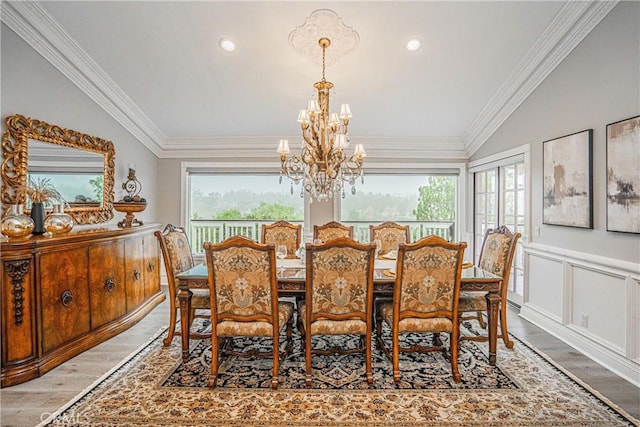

{"left": 1, "top": 0, "right": 165, "bottom": 155}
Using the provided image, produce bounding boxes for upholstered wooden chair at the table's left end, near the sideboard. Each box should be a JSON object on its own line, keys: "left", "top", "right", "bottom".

{"left": 154, "top": 224, "right": 211, "bottom": 346}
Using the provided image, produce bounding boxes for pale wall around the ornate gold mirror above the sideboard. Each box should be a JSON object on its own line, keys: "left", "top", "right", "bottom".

{"left": 0, "top": 24, "right": 160, "bottom": 226}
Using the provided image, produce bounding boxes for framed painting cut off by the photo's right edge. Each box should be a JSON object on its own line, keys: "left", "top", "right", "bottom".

{"left": 607, "top": 116, "right": 640, "bottom": 234}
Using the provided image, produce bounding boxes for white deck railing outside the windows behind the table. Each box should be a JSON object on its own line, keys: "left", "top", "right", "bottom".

{"left": 189, "top": 219, "right": 455, "bottom": 254}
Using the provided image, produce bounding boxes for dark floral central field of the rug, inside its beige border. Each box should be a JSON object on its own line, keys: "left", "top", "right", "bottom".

{"left": 163, "top": 324, "right": 518, "bottom": 390}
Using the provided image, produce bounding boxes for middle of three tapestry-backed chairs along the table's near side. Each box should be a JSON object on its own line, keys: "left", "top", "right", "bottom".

{"left": 298, "top": 237, "right": 375, "bottom": 387}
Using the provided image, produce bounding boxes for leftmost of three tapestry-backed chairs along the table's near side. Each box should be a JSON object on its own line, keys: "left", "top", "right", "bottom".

{"left": 203, "top": 236, "right": 295, "bottom": 389}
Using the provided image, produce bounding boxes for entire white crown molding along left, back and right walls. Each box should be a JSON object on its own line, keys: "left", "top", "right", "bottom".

{"left": 0, "top": 0, "right": 618, "bottom": 160}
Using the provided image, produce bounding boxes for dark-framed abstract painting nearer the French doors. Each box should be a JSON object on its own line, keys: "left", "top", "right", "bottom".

{"left": 542, "top": 129, "right": 593, "bottom": 229}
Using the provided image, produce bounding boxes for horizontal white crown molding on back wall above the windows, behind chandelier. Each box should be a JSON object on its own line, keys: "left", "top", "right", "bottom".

{"left": 158, "top": 135, "right": 468, "bottom": 160}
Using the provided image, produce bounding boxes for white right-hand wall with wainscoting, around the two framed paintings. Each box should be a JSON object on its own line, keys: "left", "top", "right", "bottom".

{"left": 473, "top": 2, "right": 640, "bottom": 384}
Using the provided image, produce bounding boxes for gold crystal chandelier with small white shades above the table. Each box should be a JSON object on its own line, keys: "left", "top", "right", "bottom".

{"left": 277, "top": 37, "right": 367, "bottom": 201}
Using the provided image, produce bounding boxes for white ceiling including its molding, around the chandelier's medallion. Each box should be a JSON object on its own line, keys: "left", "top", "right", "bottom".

{"left": 2, "top": 1, "right": 615, "bottom": 158}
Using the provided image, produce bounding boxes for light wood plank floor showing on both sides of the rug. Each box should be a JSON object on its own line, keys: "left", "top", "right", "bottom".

{"left": 0, "top": 301, "right": 640, "bottom": 426}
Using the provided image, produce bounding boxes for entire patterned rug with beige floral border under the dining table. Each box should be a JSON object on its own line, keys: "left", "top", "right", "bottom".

{"left": 42, "top": 322, "right": 638, "bottom": 427}
